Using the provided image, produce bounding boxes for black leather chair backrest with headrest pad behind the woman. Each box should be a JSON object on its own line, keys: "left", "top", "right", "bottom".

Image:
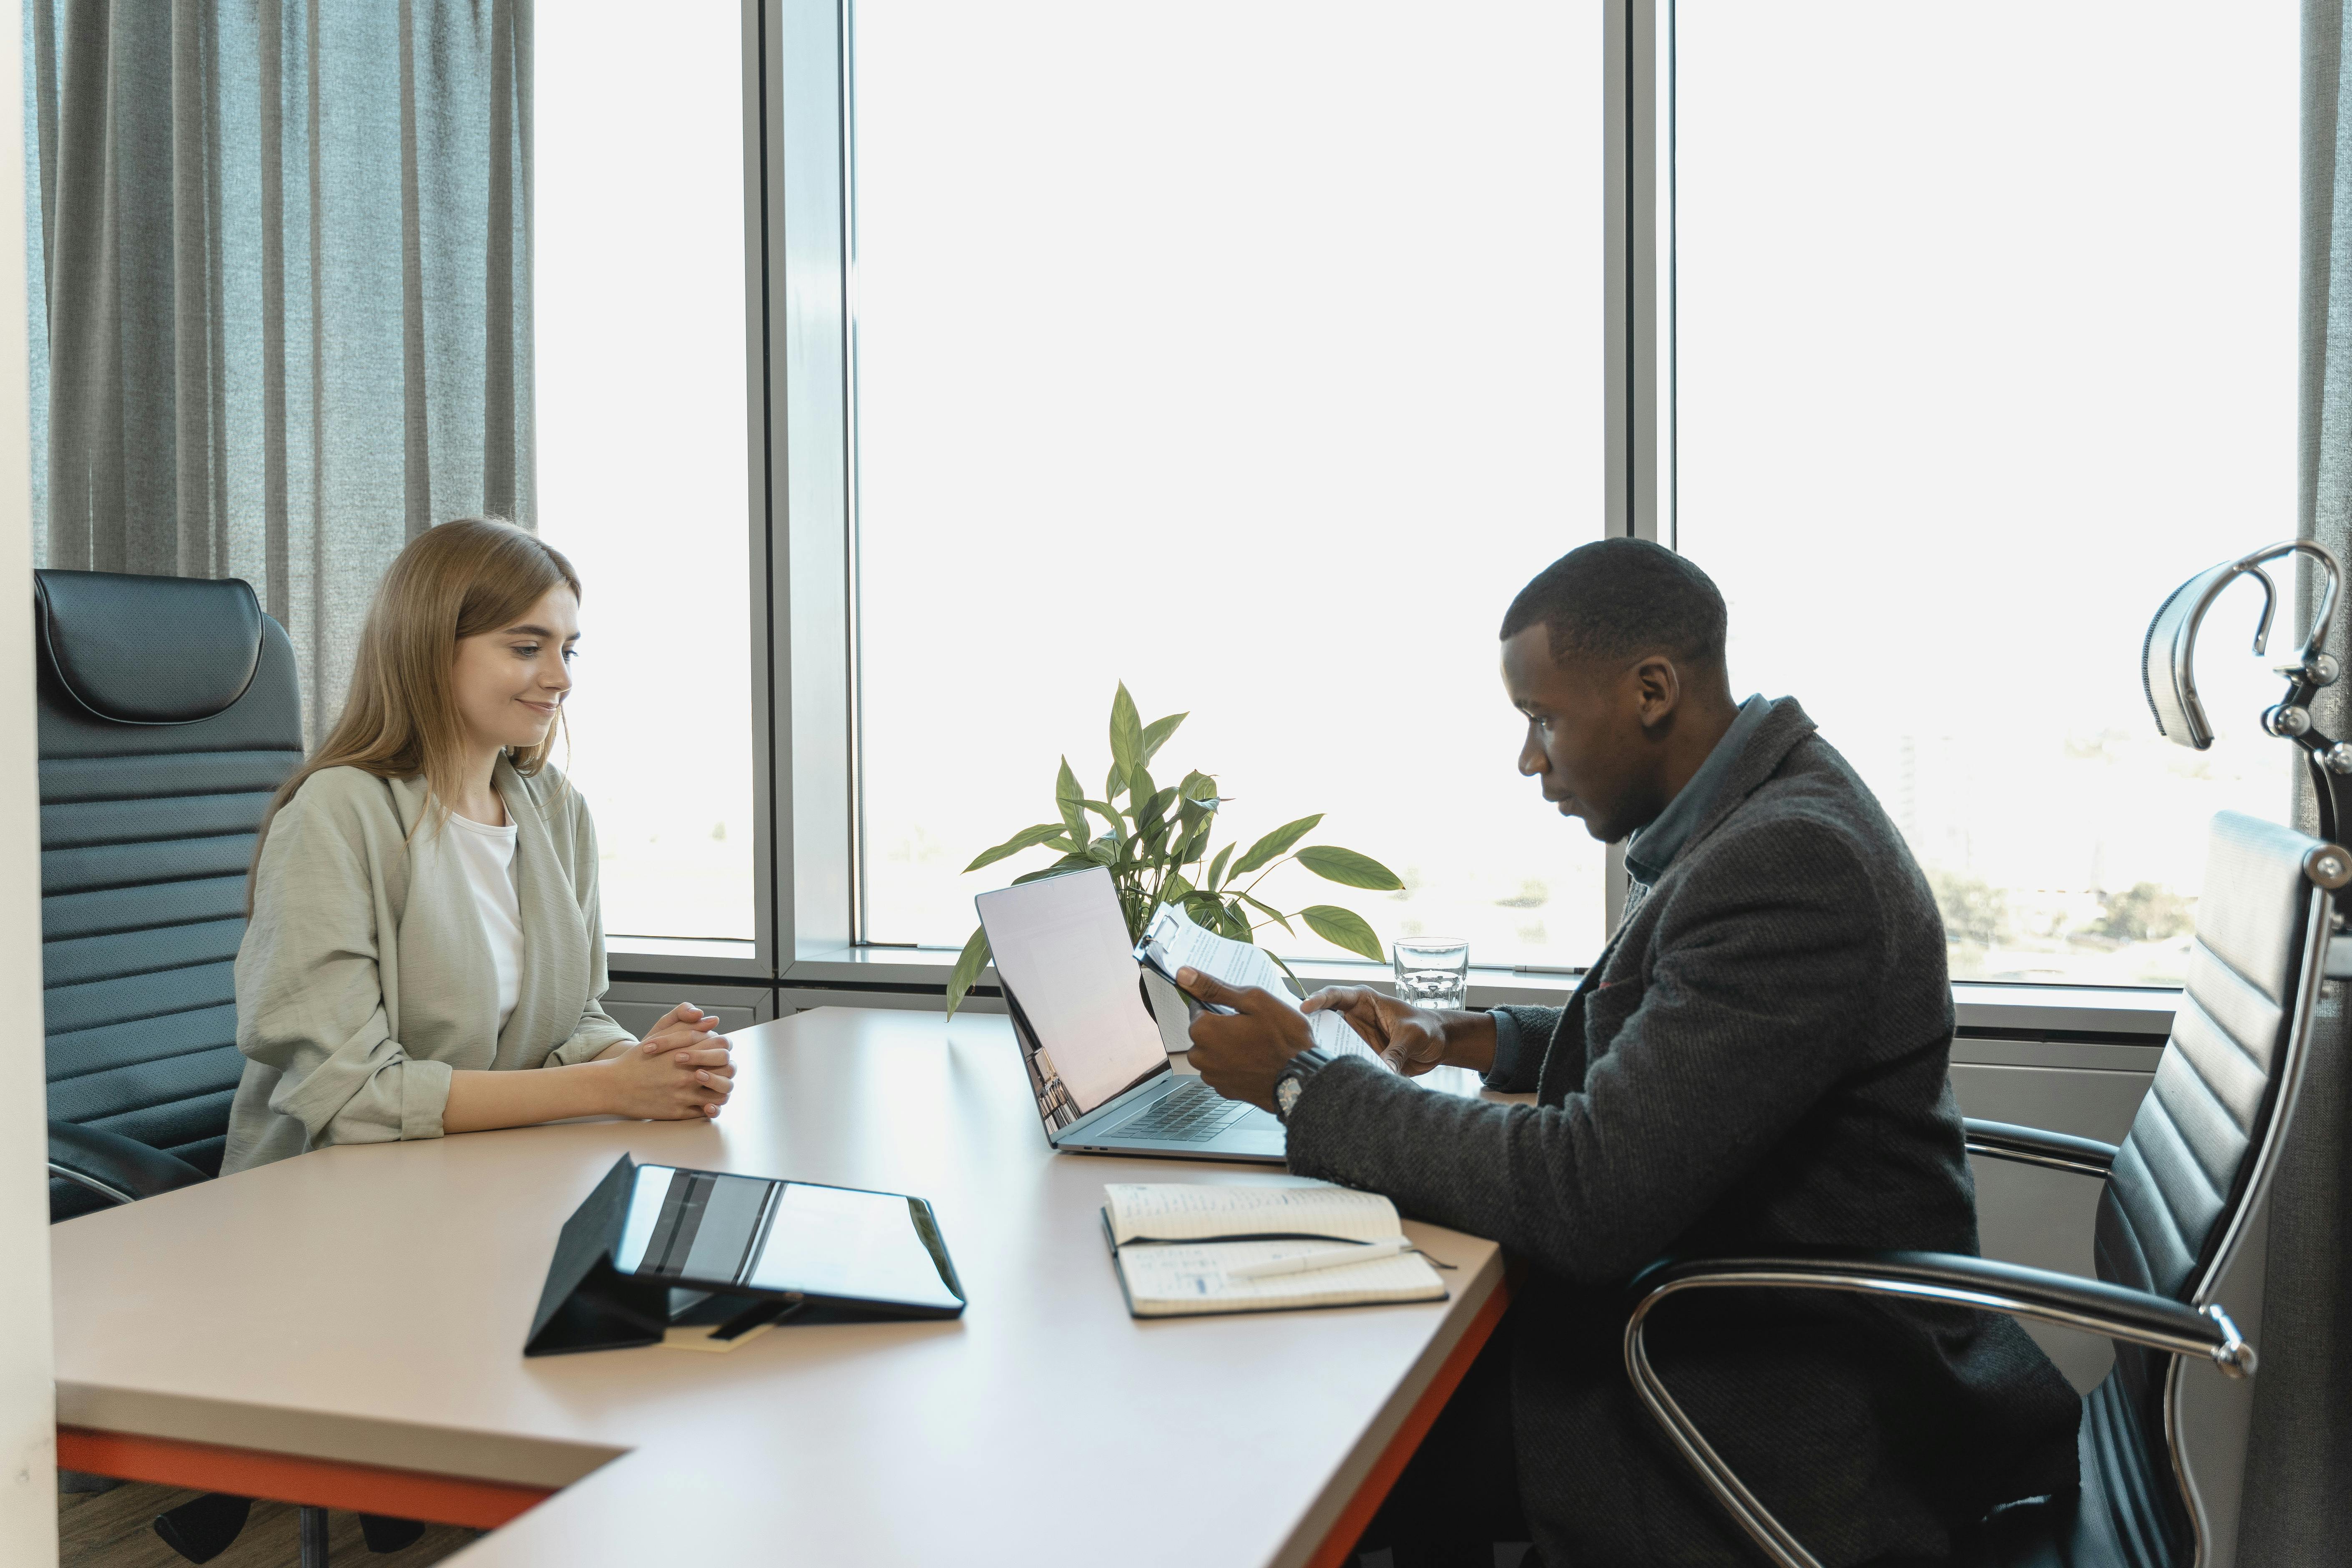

{"left": 33, "top": 571, "right": 304, "bottom": 1218}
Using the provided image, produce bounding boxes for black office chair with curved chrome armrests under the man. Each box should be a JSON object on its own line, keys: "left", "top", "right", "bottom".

{"left": 1625, "top": 541, "right": 2352, "bottom": 1568}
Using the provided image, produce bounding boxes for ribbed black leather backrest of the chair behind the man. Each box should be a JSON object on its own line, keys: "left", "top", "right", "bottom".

{"left": 2084, "top": 811, "right": 2329, "bottom": 1563}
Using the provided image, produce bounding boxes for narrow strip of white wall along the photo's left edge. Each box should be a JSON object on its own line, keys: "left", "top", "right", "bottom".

{"left": 0, "top": 3, "right": 56, "bottom": 1565}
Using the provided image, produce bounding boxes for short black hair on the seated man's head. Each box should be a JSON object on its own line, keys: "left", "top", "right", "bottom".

{"left": 1503, "top": 538, "right": 1726, "bottom": 665}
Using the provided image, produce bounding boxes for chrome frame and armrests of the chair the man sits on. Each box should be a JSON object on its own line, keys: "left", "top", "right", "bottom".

{"left": 1625, "top": 869, "right": 2342, "bottom": 1568}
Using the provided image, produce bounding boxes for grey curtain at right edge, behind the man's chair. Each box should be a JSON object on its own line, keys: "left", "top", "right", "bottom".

{"left": 2237, "top": 0, "right": 2352, "bottom": 1563}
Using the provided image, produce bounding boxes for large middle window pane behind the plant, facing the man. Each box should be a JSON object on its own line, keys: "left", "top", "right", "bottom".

{"left": 852, "top": 0, "right": 1604, "bottom": 964}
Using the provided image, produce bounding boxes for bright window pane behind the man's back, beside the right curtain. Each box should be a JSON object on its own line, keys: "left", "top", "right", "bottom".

{"left": 1672, "top": 0, "right": 2300, "bottom": 985}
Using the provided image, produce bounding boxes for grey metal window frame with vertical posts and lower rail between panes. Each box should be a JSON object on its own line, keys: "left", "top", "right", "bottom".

{"left": 609, "top": 0, "right": 2178, "bottom": 1041}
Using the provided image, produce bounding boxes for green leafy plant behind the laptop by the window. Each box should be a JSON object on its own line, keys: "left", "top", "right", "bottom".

{"left": 948, "top": 682, "right": 1404, "bottom": 1018}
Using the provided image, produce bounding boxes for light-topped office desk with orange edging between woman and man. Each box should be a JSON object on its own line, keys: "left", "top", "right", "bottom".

{"left": 52, "top": 1008, "right": 1505, "bottom": 1568}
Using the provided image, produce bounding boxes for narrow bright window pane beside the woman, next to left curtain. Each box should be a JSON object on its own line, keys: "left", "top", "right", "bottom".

{"left": 534, "top": 0, "right": 764, "bottom": 950}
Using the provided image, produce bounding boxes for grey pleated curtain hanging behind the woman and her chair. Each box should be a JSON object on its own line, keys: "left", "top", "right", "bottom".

{"left": 23, "top": 0, "right": 534, "bottom": 736}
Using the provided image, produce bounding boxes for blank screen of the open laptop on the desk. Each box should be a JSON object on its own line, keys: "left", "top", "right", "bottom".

{"left": 974, "top": 867, "right": 1166, "bottom": 1128}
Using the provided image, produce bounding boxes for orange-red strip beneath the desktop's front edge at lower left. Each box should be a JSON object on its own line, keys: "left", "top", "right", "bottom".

{"left": 56, "top": 1427, "right": 555, "bottom": 1530}
